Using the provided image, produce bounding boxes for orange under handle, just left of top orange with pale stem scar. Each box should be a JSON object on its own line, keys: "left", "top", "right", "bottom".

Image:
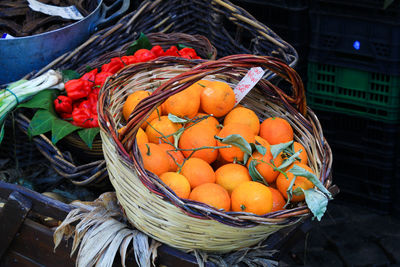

{"left": 163, "top": 87, "right": 200, "bottom": 118}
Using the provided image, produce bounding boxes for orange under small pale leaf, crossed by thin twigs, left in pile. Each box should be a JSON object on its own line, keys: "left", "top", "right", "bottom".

{"left": 146, "top": 116, "right": 182, "bottom": 144}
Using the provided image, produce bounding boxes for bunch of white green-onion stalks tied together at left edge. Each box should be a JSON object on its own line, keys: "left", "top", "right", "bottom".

{"left": 0, "top": 70, "right": 64, "bottom": 144}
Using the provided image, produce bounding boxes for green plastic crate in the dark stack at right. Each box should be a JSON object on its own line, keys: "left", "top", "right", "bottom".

{"left": 307, "top": 62, "right": 400, "bottom": 122}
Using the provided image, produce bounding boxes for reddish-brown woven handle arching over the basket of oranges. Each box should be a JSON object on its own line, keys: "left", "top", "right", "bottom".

{"left": 118, "top": 54, "right": 307, "bottom": 151}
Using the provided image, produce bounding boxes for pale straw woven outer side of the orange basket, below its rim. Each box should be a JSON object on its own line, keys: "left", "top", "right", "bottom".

{"left": 101, "top": 132, "right": 302, "bottom": 253}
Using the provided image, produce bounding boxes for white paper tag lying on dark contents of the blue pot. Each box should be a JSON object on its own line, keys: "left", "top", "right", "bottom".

{"left": 28, "top": 0, "right": 83, "bottom": 20}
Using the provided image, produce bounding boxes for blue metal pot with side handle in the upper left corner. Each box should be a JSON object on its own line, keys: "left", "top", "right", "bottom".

{"left": 0, "top": 0, "right": 130, "bottom": 85}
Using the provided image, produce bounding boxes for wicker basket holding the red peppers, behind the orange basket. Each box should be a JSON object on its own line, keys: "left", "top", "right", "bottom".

{"left": 17, "top": 33, "right": 217, "bottom": 187}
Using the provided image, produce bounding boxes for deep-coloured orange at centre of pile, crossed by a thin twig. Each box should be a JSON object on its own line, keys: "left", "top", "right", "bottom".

{"left": 179, "top": 124, "right": 218, "bottom": 164}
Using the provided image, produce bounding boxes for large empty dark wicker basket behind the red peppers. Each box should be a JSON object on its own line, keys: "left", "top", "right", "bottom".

{"left": 27, "top": 0, "right": 298, "bottom": 78}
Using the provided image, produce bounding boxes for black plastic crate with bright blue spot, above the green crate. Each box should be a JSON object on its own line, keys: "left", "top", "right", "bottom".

{"left": 308, "top": 7, "right": 400, "bottom": 75}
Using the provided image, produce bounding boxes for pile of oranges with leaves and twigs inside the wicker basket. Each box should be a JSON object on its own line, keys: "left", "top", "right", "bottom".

{"left": 123, "top": 80, "right": 314, "bottom": 215}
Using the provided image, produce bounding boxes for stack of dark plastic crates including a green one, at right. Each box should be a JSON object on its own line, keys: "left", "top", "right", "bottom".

{"left": 307, "top": 0, "right": 400, "bottom": 214}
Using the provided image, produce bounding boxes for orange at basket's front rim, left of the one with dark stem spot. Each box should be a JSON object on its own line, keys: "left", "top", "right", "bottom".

{"left": 189, "top": 183, "right": 231, "bottom": 211}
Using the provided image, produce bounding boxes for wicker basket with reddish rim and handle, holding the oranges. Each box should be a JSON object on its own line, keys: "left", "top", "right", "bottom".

{"left": 99, "top": 55, "right": 332, "bottom": 252}
